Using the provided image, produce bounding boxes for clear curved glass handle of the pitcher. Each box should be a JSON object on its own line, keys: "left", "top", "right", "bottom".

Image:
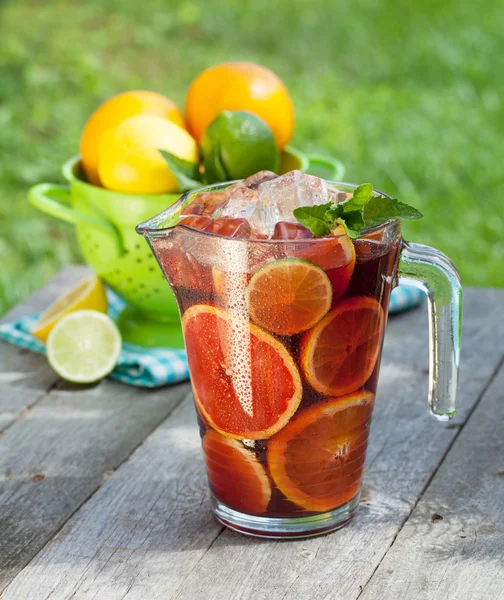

{"left": 399, "top": 241, "right": 462, "bottom": 421}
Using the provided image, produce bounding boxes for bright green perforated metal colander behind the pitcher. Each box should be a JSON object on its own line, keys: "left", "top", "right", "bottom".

{"left": 29, "top": 156, "right": 184, "bottom": 348}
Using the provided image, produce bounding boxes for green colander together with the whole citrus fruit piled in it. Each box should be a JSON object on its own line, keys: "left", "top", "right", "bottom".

{"left": 29, "top": 63, "right": 342, "bottom": 347}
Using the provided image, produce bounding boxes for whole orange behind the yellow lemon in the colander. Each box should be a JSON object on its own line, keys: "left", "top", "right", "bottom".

{"left": 80, "top": 90, "right": 186, "bottom": 185}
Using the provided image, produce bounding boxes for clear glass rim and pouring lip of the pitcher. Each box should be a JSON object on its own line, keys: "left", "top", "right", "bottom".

{"left": 135, "top": 178, "right": 400, "bottom": 244}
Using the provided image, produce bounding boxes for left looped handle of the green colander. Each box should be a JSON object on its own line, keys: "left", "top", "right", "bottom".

{"left": 28, "top": 183, "right": 121, "bottom": 240}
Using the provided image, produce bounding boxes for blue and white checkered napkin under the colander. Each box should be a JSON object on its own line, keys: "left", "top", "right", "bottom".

{"left": 0, "top": 286, "right": 423, "bottom": 388}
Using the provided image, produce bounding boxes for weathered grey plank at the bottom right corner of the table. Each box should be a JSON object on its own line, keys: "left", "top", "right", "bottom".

{"left": 361, "top": 360, "right": 504, "bottom": 600}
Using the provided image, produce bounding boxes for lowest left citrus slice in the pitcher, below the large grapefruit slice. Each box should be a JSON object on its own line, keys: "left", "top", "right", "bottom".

{"left": 202, "top": 429, "right": 271, "bottom": 515}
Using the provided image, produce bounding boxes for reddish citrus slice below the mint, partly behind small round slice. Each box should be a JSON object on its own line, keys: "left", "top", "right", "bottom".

{"left": 292, "top": 225, "right": 355, "bottom": 302}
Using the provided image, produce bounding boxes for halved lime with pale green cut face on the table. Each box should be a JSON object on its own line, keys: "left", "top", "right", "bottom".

{"left": 47, "top": 310, "right": 121, "bottom": 383}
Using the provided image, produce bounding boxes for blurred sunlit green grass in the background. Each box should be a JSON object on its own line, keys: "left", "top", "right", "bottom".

{"left": 0, "top": 0, "right": 504, "bottom": 314}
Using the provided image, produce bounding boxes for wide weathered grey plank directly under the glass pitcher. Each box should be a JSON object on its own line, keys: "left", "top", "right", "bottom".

{"left": 5, "top": 290, "right": 504, "bottom": 600}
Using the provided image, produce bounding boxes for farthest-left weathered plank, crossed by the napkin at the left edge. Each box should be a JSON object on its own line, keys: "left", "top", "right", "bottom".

{"left": 0, "top": 267, "right": 90, "bottom": 431}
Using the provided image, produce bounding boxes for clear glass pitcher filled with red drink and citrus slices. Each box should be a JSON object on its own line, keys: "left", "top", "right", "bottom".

{"left": 137, "top": 182, "right": 462, "bottom": 537}
